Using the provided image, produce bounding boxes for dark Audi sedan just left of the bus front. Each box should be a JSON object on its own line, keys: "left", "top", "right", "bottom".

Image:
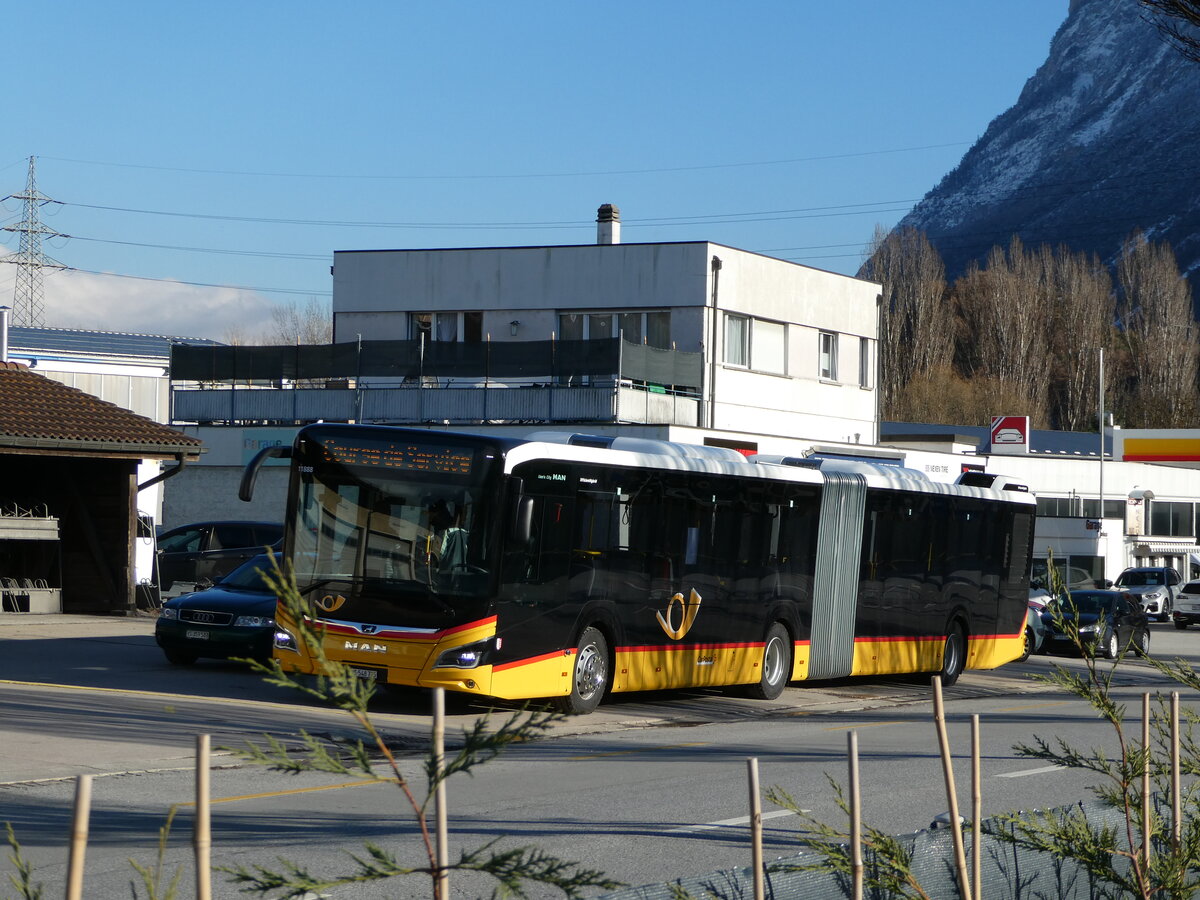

{"left": 154, "top": 553, "right": 275, "bottom": 666}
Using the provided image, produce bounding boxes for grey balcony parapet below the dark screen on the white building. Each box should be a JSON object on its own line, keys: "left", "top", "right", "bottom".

{"left": 170, "top": 382, "right": 701, "bottom": 426}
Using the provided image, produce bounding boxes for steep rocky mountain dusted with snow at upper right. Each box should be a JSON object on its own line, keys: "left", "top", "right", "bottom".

{"left": 899, "top": 0, "right": 1200, "bottom": 293}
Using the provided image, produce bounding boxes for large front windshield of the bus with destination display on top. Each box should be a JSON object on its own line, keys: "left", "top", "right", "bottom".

{"left": 292, "top": 434, "right": 497, "bottom": 596}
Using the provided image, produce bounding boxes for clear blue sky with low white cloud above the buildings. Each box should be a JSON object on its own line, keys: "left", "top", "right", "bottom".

{"left": 0, "top": 0, "right": 1067, "bottom": 340}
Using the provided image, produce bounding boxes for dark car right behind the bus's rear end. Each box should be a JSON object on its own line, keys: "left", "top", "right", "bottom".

{"left": 1042, "top": 590, "right": 1150, "bottom": 659}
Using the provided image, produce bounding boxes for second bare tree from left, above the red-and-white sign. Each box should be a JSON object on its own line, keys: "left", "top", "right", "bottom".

{"left": 954, "top": 236, "right": 1051, "bottom": 427}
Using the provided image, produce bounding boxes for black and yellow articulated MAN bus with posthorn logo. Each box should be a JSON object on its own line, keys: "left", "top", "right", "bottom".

{"left": 241, "top": 424, "right": 1034, "bottom": 713}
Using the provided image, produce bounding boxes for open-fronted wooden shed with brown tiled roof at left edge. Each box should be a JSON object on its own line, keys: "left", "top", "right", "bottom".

{"left": 0, "top": 361, "right": 202, "bottom": 614}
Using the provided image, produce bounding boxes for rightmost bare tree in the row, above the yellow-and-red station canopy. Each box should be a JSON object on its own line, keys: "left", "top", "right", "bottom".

{"left": 1117, "top": 232, "right": 1200, "bottom": 428}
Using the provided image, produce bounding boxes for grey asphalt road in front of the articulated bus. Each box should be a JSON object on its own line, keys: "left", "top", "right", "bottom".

{"left": 0, "top": 617, "right": 1200, "bottom": 900}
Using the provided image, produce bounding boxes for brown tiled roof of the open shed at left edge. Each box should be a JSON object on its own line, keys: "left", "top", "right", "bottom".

{"left": 0, "top": 362, "right": 203, "bottom": 456}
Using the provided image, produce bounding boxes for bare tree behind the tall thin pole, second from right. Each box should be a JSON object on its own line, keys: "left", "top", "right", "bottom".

{"left": 1043, "top": 246, "right": 1116, "bottom": 431}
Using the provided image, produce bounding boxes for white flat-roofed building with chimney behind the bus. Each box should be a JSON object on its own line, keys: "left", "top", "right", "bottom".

{"left": 334, "top": 206, "right": 880, "bottom": 444}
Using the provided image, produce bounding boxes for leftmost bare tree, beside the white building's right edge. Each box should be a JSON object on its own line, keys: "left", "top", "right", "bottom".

{"left": 859, "top": 227, "right": 954, "bottom": 419}
